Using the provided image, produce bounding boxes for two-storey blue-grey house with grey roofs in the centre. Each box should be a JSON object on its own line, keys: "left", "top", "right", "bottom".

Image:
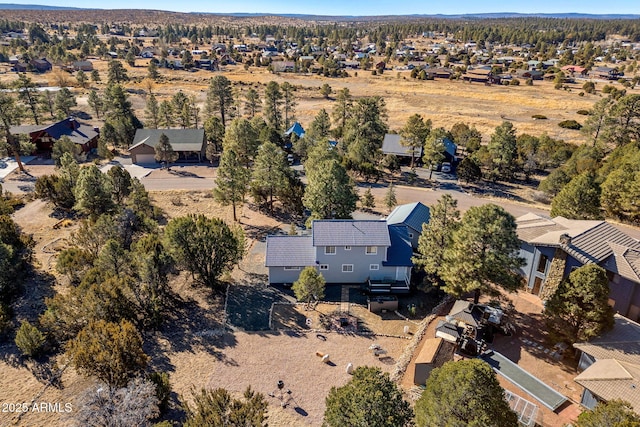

{"left": 265, "top": 220, "right": 413, "bottom": 293}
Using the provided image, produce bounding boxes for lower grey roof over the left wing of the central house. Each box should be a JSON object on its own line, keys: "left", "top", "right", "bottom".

{"left": 265, "top": 236, "right": 316, "bottom": 267}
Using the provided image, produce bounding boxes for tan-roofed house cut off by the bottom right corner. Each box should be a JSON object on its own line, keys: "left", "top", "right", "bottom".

{"left": 573, "top": 314, "right": 640, "bottom": 414}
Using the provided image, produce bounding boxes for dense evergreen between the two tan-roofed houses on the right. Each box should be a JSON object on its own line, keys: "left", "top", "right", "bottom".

{"left": 543, "top": 264, "right": 613, "bottom": 344}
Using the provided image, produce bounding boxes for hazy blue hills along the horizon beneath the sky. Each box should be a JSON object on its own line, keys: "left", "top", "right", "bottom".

{"left": 0, "top": 3, "right": 640, "bottom": 21}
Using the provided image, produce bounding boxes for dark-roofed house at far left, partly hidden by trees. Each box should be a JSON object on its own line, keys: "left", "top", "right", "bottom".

{"left": 10, "top": 117, "right": 100, "bottom": 156}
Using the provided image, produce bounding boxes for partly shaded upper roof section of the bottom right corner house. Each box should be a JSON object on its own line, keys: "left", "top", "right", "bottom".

{"left": 573, "top": 314, "right": 640, "bottom": 365}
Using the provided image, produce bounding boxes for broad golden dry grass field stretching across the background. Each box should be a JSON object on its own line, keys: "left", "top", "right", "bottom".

{"left": 0, "top": 55, "right": 628, "bottom": 144}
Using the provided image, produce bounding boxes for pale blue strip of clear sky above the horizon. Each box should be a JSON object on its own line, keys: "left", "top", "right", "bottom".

{"left": 0, "top": 0, "right": 640, "bottom": 15}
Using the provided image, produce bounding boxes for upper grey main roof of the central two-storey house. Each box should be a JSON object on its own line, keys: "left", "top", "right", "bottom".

{"left": 312, "top": 219, "right": 391, "bottom": 247}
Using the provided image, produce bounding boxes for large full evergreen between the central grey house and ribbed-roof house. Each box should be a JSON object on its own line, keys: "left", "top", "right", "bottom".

{"left": 439, "top": 204, "right": 523, "bottom": 303}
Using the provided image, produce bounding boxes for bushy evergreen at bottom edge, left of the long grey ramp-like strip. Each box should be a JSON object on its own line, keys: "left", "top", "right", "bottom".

{"left": 415, "top": 359, "right": 518, "bottom": 427}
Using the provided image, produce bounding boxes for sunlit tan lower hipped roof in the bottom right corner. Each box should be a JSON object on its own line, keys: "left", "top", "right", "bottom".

{"left": 575, "top": 359, "right": 640, "bottom": 412}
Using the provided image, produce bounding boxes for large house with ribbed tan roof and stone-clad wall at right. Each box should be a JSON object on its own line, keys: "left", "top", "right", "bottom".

{"left": 516, "top": 213, "right": 640, "bottom": 320}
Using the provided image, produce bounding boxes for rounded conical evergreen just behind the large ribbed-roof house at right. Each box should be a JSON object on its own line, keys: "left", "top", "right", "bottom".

{"left": 551, "top": 171, "right": 602, "bottom": 219}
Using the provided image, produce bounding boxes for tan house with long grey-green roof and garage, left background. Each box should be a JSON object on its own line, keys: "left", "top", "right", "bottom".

{"left": 129, "top": 129, "right": 206, "bottom": 164}
